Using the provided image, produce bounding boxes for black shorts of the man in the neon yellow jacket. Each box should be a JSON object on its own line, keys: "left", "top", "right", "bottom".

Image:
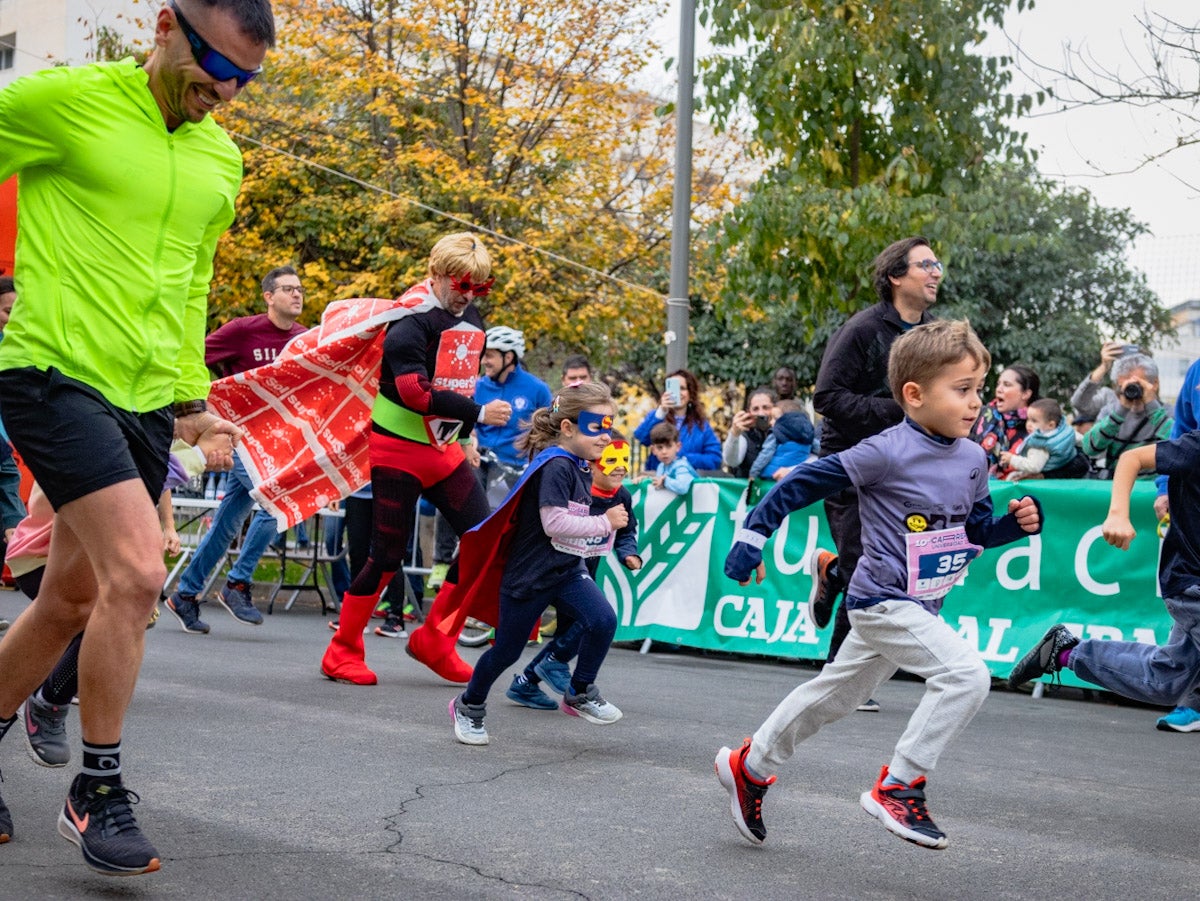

{"left": 0, "top": 366, "right": 175, "bottom": 508}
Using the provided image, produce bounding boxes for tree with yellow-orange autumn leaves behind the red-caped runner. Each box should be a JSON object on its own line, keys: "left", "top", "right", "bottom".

{"left": 214, "top": 0, "right": 733, "bottom": 367}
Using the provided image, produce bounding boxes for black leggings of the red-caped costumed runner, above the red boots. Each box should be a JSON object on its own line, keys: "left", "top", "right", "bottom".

{"left": 349, "top": 461, "right": 488, "bottom": 596}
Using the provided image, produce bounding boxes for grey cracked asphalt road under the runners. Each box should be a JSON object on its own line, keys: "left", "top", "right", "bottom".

{"left": 0, "top": 591, "right": 1200, "bottom": 901}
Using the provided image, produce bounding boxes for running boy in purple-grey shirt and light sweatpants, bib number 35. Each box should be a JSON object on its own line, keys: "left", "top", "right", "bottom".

{"left": 715, "top": 320, "right": 1042, "bottom": 849}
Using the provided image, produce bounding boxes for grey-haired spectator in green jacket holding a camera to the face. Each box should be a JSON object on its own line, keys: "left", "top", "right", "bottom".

{"left": 1082, "top": 354, "right": 1175, "bottom": 479}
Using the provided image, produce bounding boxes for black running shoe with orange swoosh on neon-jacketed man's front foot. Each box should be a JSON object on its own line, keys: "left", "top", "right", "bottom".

{"left": 59, "top": 773, "right": 160, "bottom": 876}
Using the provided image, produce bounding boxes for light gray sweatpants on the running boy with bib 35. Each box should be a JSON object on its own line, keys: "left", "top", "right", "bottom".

{"left": 746, "top": 601, "right": 991, "bottom": 782}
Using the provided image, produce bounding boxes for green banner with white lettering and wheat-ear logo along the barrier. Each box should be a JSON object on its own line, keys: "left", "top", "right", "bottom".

{"left": 596, "top": 479, "right": 1171, "bottom": 685}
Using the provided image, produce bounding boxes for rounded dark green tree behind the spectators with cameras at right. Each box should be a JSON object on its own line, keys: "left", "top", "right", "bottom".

{"left": 937, "top": 166, "right": 1171, "bottom": 401}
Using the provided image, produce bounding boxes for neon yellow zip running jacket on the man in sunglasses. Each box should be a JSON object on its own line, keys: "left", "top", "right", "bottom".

{"left": 0, "top": 59, "right": 241, "bottom": 413}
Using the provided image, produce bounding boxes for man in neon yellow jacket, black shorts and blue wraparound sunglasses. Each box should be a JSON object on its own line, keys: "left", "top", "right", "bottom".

{"left": 0, "top": 0, "right": 275, "bottom": 875}
